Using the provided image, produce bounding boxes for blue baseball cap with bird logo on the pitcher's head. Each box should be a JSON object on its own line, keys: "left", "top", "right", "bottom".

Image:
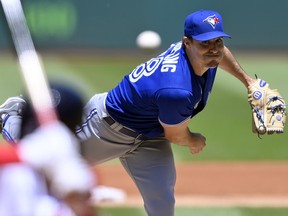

{"left": 184, "top": 10, "right": 231, "bottom": 41}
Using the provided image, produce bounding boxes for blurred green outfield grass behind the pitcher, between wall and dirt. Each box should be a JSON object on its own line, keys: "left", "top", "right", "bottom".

{"left": 0, "top": 53, "right": 288, "bottom": 161}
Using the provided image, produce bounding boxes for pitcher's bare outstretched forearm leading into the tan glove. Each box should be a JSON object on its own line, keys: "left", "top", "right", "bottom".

{"left": 219, "top": 47, "right": 256, "bottom": 87}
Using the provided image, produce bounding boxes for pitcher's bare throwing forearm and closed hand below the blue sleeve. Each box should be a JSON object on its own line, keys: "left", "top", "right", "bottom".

{"left": 161, "top": 121, "right": 206, "bottom": 154}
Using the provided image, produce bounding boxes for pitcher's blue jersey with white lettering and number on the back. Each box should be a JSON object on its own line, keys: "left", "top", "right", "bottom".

{"left": 106, "top": 42, "right": 217, "bottom": 138}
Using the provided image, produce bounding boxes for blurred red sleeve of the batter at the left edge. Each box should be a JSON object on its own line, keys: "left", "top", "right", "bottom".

{"left": 0, "top": 144, "right": 21, "bottom": 165}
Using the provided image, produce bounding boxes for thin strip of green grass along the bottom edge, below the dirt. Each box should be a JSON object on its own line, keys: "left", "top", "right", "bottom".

{"left": 100, "top": 207, "right": 288, "bottom": 216}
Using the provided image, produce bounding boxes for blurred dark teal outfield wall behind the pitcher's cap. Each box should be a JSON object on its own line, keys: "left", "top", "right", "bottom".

{"left": 0, "top": 0, "right": 288, "bottom": 51}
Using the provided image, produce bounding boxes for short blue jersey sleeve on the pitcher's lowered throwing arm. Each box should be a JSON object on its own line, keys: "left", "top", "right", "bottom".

{"left": 155, "top": 89, "right": 196, "bottom": 125}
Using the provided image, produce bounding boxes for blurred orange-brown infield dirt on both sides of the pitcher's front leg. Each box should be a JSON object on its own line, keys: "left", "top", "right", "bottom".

{"left": 97, "top": 161, "right": 288, "bottom": 207}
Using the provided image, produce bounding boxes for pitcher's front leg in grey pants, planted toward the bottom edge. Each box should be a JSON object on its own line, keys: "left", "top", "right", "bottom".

{"left": 120, "top": 140, "right": 176, "bottom": 216}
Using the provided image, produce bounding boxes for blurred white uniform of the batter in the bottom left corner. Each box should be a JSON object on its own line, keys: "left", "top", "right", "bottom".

{"left": 0, "top": 163, "right": 75, "bottom": 216}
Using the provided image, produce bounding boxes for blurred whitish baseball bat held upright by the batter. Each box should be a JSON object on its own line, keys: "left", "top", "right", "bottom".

{"left": 1, "top": 0, "right": 57, "bottom": 125}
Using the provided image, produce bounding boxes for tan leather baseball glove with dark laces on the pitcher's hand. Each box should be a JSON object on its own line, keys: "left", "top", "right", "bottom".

{"left": 248, "top": 79, "right": 286, "bottom": 135}
